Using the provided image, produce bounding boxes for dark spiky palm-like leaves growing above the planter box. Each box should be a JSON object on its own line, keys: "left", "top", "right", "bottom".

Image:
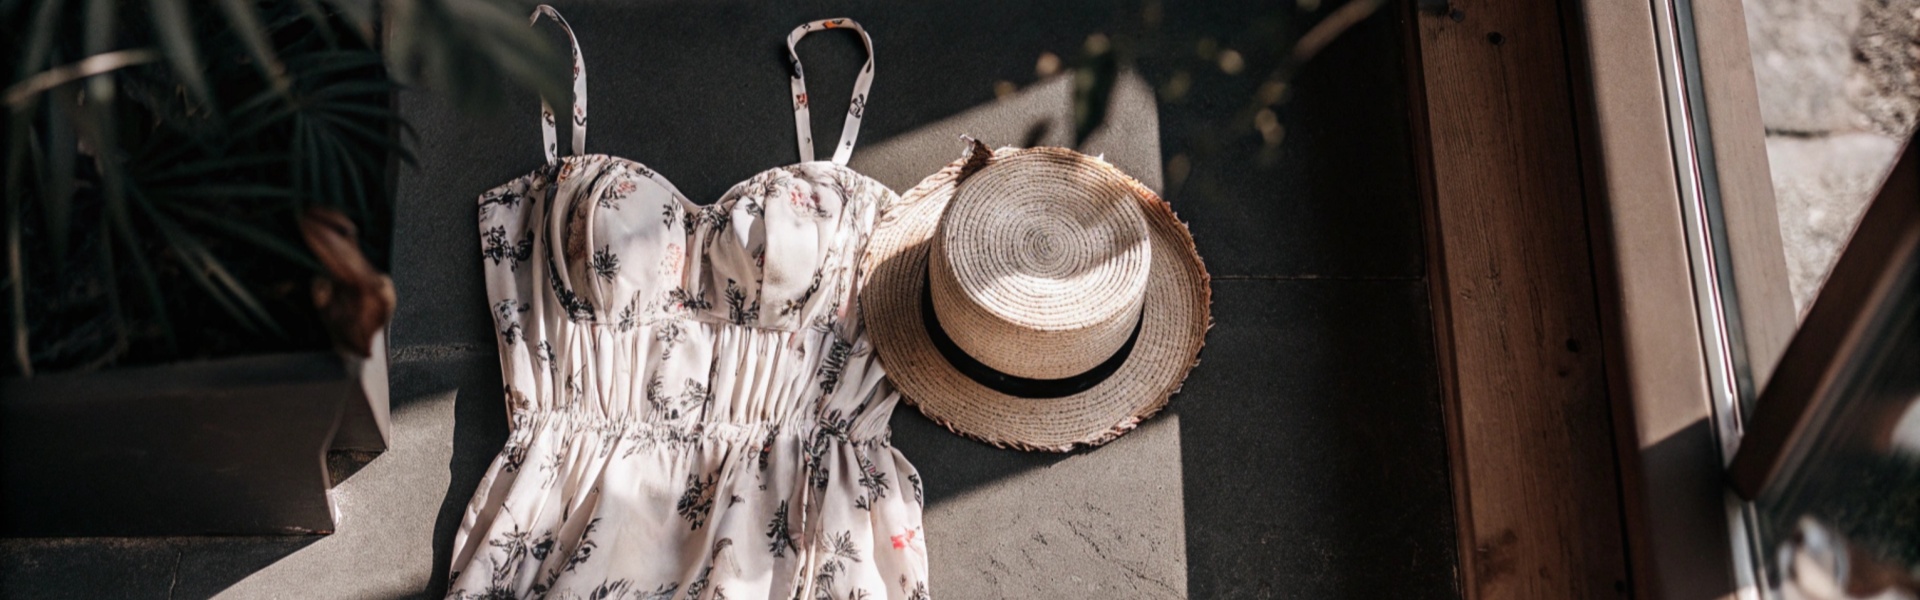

{"left": 0, "top": 0, "right": 564, "bottom": 375}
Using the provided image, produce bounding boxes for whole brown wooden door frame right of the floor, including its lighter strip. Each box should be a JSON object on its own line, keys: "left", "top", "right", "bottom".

{"left": 1404, "top": 0, "right": 1795, "bottom": 598}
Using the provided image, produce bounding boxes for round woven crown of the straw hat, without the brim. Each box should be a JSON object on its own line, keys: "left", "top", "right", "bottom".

{"left": 927, "top": 154, "right": 1152, "bottom": 379}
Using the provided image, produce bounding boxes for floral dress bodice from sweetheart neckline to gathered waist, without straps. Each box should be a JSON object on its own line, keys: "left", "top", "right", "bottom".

{"left": 480, "top": 156, "right": 893, "bottom": 426}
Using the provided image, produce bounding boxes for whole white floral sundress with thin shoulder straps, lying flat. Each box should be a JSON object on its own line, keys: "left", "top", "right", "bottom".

{"left": 447, "top": 6, "right": 927, "bottom": 600}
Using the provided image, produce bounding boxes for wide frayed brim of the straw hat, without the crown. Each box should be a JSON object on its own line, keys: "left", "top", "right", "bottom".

{"left": 860, "top": 148, "right": 1212, "bottom": 452}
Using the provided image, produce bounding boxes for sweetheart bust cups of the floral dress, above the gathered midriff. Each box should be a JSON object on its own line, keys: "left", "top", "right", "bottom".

{"left": 480, "top": 154, "right": 893, "bottom": 338}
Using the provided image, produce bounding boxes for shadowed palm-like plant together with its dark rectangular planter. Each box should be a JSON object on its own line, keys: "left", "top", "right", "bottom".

{"left": 0, "top": 0, "right": 564, "bottom": 535}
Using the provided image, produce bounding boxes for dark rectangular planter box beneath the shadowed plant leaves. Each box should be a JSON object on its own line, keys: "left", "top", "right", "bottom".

{"left": 0, "top": 335, "right": 390, "bottom": 537}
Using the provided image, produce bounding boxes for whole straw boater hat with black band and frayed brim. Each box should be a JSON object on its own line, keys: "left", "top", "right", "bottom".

{"left": 860, "top": 140, "right": 1212, "bottom": 452}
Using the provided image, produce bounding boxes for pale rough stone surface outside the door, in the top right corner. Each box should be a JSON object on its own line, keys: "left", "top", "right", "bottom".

{"left": 1743, "top": 0, "right": 1920, "bottom": 315}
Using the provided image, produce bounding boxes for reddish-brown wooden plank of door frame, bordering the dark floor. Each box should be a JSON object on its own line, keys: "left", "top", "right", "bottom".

{"left": 1415, "top": 0, "right": 1628, "bottom": 598}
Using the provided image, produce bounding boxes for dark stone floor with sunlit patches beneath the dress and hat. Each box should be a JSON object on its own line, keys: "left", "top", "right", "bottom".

{"left": 0, "top": 0, "right": 1459, "bottom": 598}
